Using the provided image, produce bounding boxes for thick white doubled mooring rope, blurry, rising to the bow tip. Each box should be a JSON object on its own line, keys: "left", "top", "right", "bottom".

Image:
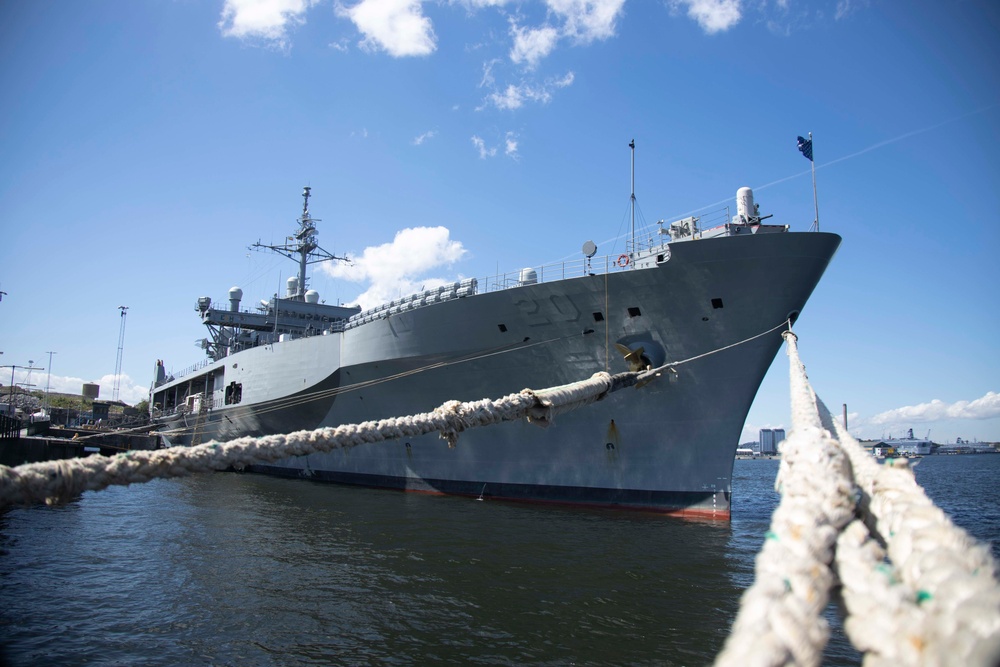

{"left": 716, "top": 332, "right": 1000, "bottom": 667}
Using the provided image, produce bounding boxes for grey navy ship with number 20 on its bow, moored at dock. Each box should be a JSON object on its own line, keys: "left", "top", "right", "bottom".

{"left": 150, "top": 175, "right": 841, "bottom": 520}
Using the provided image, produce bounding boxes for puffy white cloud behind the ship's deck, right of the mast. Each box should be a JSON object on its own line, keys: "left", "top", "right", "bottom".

{"left": 321, "top": 227, "right": 466, "bottom": 308}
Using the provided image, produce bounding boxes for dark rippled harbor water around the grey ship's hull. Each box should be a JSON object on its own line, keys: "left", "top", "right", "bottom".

{"left": 0, "top": 455, "right": 1000, "bottom": 666}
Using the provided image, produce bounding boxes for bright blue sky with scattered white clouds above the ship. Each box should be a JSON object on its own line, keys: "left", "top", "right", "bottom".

{"left": 0, "top": 0, "right": 1000, "bottom": 442}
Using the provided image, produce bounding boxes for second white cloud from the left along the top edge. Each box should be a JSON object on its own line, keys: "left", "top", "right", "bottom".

{"left": 336, "top": 0, "right": 437, "bottom": 58}
